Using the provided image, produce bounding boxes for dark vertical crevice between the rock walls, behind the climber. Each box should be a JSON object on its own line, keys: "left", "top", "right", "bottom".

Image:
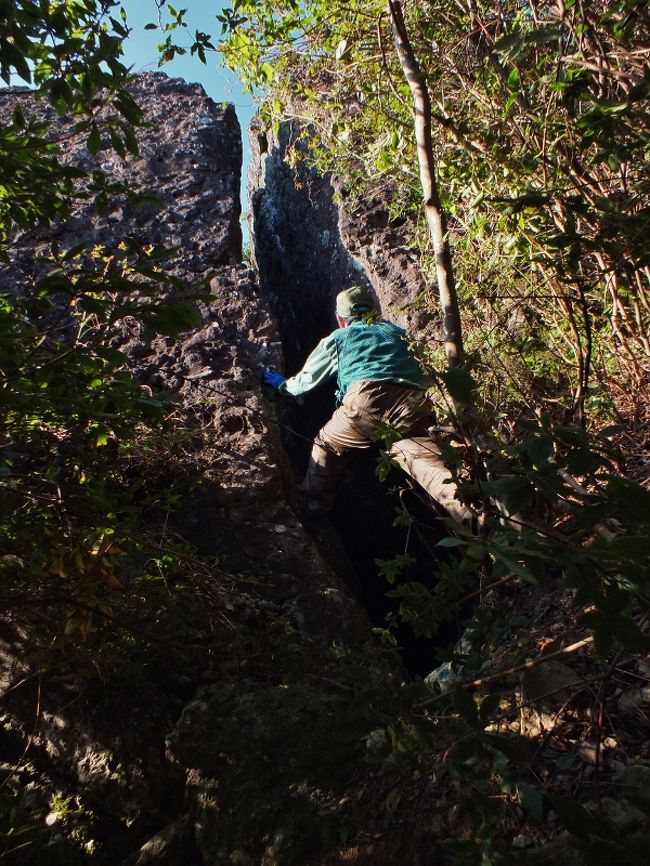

{"left": 251, "top": 125, "right": 466, "bottom": 674}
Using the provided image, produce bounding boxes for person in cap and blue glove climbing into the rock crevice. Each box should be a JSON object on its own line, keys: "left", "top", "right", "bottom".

{"left": 263, "top": 286, "right": 471, "bottom": 521}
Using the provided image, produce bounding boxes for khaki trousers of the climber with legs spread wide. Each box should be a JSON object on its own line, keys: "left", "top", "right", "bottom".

{"left": 300, "top": 380, "right": 471, "bottom": 521}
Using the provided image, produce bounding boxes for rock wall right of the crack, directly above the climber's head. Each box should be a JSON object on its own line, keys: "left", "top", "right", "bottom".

{"left": 249, "top": 115, "right": 430, "bottom": 370}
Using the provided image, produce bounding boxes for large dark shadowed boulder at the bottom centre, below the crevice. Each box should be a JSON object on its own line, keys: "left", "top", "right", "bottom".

{"left": 168, "top": 682, "right": 368, "bottom": 866}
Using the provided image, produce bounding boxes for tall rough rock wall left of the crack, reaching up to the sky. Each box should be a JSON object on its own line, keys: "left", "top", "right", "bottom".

{"left": 0, "top": 73, "right": 370, "bottom": 637}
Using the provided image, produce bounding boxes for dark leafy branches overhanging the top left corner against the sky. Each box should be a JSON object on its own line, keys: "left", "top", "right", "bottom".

{"left": 0, "top": 0, "right": 142, "bottom": 233}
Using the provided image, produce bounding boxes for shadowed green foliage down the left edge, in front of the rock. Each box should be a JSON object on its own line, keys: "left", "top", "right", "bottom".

{"left": 0, "top": 0, "right": 202, "bottom": 634}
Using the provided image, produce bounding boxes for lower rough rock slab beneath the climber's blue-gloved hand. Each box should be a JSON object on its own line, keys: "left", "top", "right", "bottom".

{"left": 136, "top": 265, "right": 365, "bottom": 646}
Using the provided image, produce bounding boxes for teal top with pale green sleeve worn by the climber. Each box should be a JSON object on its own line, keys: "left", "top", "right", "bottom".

{"left": 280, "top": 321, "right": 427, "bottom": 404}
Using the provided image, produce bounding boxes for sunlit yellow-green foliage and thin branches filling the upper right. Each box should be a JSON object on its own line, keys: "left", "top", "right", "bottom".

{"left": 194, "top": 0, "right": 650, "bottom": 419}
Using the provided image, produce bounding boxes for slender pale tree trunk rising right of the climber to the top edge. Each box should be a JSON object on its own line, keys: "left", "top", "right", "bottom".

{"left": 388, "top": 0, "right": 463, "bottom": 367}
